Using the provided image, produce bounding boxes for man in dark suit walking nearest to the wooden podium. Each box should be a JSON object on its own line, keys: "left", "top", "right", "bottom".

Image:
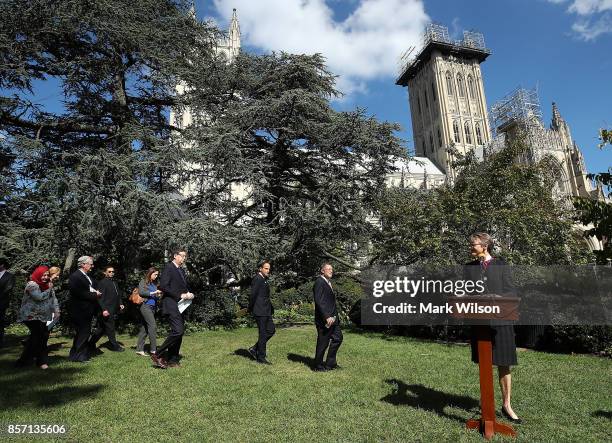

{"left": 313, "top": 263, "right": 342, "bottom": 371}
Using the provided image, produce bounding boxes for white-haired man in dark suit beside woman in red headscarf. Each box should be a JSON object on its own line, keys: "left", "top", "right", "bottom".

{"left": 68, "top": 255, "right": 102, "bottom": 362}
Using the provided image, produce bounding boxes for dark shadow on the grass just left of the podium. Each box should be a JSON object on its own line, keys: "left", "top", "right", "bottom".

{"left": 380, "top": 379, "right": 480, "bottom": 423}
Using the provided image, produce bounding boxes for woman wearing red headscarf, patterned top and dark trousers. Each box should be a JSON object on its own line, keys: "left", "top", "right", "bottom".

{"left": 17, "top": 266, "right": 59, "bottom": 369}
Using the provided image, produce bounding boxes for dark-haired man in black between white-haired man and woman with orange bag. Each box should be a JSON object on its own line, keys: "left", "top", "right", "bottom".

{"left": 89, "top": 266, "right": 125, "bottom": 353}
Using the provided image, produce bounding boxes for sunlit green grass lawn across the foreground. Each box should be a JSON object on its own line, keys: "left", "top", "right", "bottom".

{"left": 0, "top": 327, "right": 612, "bottom": 442}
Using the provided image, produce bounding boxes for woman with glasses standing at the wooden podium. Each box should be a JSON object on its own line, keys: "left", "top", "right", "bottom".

{"left": 465, "top": 232, "right": 521, "bottom": 423}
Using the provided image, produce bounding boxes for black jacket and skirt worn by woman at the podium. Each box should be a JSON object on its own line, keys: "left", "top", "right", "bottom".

{"left": 464, "top": 258, "right": 517, "bottom": 366}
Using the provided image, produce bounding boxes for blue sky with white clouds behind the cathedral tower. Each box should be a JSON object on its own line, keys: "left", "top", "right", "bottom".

{"left": 202, "top": 0, "right": 612, "bottom": 176}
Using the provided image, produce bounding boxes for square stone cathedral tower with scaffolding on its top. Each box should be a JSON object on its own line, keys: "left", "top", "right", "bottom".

{"left": 396, "top": 23, "right": 491, "bottom": 178}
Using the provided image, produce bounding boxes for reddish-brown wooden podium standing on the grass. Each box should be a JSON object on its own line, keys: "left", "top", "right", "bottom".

{"left": 447, "top": 295, "right": 520, "bottom": 440}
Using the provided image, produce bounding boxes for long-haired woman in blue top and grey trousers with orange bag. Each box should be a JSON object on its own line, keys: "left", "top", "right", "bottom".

{"left": 136, "top": 268, "right": 162, "bottom": 356}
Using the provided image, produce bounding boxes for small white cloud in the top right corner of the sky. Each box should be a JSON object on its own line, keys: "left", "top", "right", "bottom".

{"left": 548, "top": 0, "right": 612, "bottom": 41}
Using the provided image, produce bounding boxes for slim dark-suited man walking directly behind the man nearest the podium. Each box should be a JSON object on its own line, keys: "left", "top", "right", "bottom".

{"left": 249, "top": 260, "right": 276, "bottom": 365}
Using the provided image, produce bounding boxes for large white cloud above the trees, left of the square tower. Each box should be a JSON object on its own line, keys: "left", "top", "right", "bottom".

{"left": 214, "top": 0, "right": 430, "bottom": 94}
